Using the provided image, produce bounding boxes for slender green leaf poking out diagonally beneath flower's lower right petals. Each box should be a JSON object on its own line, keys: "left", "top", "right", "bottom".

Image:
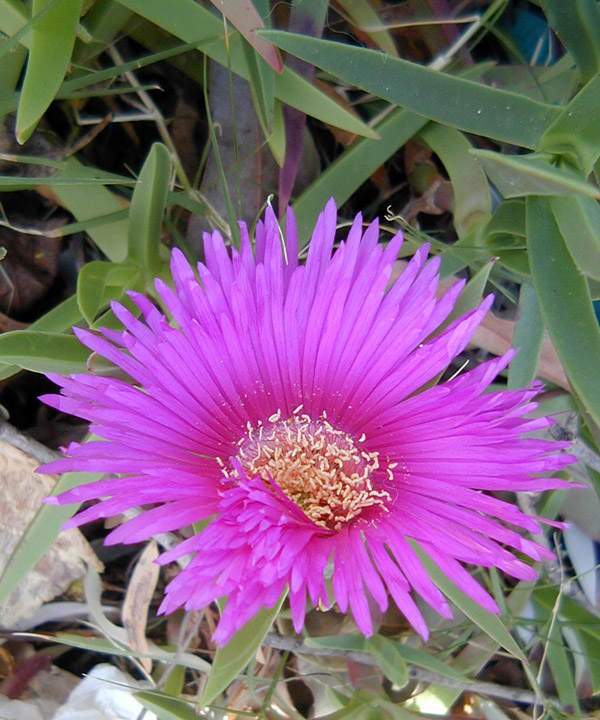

{"left": 411, "top": 543, "right": 527, "bottom": 664}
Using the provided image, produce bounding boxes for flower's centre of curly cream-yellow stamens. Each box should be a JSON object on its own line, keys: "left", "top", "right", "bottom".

{"left": 225, "top": 409, "right": 392, "bottom": 530}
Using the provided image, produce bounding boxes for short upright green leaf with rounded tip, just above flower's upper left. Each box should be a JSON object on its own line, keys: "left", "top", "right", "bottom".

{"left": 128, "top": 143, "right": 172, "bottom": 277}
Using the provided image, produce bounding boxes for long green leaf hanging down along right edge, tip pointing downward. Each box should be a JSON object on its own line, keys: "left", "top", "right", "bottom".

{"left": 527, "top": 197, "right": 600, "bottom": 424}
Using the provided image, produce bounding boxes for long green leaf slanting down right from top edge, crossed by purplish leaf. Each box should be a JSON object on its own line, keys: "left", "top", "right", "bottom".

{"left": 119, "top": 0, "right": 375, "bottom": 137}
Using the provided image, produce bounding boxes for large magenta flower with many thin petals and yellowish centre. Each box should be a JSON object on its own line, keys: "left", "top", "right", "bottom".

{"left": 43, "top": 201, "right": 573, "bottom": 644}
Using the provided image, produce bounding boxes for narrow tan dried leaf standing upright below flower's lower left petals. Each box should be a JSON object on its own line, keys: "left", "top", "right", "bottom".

{"left": 121, "top": 540, "right": 160, "bottom": 674}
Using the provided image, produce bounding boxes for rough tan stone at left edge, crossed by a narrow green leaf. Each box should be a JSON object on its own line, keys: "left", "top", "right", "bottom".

{"left": 0, "top": 441, "right": 103, "bottom": 627}
